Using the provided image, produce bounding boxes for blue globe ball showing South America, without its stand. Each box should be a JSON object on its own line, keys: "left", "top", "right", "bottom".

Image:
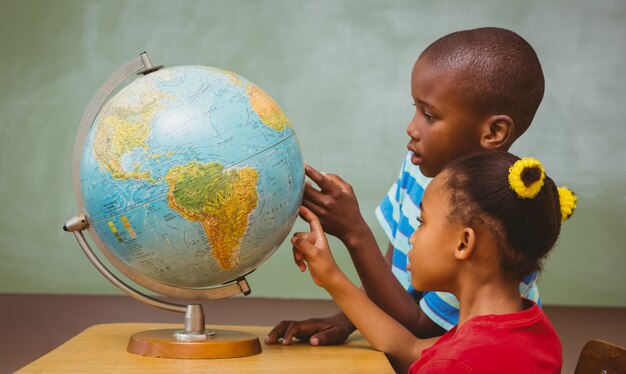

{"left": 79, "top": 65, "right": 304, "bottom": 288}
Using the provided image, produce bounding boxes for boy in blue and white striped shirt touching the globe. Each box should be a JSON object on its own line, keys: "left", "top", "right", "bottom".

{"left": 266, "top": 28, "right": 544, "bottom": 345}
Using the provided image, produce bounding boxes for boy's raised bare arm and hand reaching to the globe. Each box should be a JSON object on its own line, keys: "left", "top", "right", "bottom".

{"left": 302, "top": 165, "right": 445, "bottom": 338}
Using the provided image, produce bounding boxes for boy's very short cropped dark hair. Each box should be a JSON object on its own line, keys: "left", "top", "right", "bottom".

{"left": 420, "top": 27, "right": 544, "bottom": 139}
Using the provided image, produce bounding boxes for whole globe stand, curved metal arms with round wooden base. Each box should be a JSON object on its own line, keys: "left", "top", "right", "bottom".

{"left": 63, "top": 52, "right": 261, "bottom": 358}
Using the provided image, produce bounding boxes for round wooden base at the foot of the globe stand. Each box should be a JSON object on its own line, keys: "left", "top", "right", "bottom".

{"left": 126, "top": 329, "right": 261, "bottom": 358}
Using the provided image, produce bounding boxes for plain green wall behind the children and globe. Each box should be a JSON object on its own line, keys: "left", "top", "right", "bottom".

{"left": 0, "top": 0, "right": 626, "bottom": 306}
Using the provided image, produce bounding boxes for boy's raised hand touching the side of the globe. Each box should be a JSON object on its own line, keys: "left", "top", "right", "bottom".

{"left": 302, "top": 164, "right": 368, "bottom": 246}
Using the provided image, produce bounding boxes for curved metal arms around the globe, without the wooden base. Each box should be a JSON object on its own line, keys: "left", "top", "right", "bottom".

{"left": 65, "top": 52, "right": 250, "bottom": 304}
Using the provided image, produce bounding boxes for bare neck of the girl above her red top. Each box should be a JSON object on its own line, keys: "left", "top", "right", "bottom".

{"left": 458, "top": 280, "right": 524, "bottom": 327}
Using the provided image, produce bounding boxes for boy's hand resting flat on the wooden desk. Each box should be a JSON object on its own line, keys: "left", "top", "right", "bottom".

{"left": 265, "top": 316, "right": 354, "bottom": 345}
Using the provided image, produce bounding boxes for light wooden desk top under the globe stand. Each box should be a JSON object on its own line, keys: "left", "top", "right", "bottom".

{"left": 18, "top": 323, "right": 393, "bottom": 373}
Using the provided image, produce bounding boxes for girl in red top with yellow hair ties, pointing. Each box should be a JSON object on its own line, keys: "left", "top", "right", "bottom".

{"left": 292, "top": 151, "right": 576, "bottom": 373}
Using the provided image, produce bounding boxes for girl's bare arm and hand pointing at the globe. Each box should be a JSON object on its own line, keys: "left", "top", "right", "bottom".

{"left": 292, "top": 208, "right": 436, "bottom": 372}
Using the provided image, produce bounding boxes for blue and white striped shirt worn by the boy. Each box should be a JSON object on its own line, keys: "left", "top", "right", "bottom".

{"left": 376, "top": 152, "right": 540, "bottom": 330}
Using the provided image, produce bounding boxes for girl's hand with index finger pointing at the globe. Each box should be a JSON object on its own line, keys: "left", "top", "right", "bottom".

{"left": 291, "top": 206, "right": 342, "bottom": 288}
